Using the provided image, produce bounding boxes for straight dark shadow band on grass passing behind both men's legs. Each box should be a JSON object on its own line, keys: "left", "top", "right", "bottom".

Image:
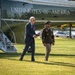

{"left": 0, "top": 53, "right": 75, "bottom": 58}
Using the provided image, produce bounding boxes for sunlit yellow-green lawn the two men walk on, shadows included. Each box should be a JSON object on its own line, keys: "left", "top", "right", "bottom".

{"left": 0, "top": 38, "right": 75, "bottom": 75}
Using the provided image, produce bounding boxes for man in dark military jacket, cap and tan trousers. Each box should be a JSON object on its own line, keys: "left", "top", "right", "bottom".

{"left": 42, "top": 21, "right": 55, "bottom": 61}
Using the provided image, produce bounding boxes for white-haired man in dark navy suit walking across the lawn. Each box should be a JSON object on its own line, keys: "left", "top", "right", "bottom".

{"left": 20, "top": 17, "right": 38, "bottom": 61}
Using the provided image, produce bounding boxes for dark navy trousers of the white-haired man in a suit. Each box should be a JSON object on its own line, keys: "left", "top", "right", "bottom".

{"left": 20, "top": 41, "right": 35, "bottom": 60}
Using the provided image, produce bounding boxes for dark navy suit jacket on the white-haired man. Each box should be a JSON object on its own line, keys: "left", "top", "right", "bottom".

{"left": 25, "top": 23, "right": 35, "bottom": 43}
